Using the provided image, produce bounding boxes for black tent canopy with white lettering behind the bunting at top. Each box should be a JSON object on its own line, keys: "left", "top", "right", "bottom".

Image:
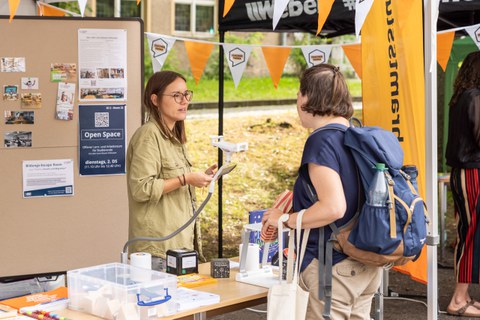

{"left": 219, "top": 0, "right": 480, "bottom": 37}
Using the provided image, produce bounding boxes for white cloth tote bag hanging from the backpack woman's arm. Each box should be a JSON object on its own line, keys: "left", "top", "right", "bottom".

{"left": 267, "top": 210, "right": 310, "bottom": 320}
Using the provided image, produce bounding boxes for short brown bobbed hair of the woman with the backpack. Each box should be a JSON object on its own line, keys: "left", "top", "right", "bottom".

{"left": 300, "top": 63, "right": 353, "bottom": 119}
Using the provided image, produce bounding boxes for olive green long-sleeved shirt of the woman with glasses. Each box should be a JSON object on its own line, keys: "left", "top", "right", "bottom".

{"left": 127, "top": 119, "right": 202, "bottom": 259}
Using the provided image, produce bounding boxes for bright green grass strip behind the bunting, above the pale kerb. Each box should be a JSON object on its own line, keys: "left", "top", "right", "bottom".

{"left": 187, "top": 77, "right": 362, "bottom": 102}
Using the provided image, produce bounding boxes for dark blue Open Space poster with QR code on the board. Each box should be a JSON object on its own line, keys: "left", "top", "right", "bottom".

{"left": 78, "top": 105, "right": 127, "bottom": 175}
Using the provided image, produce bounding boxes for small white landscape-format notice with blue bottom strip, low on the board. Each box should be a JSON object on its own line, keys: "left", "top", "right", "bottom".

{"left": 23, "top": 159, "right": 73, "bottom": 198}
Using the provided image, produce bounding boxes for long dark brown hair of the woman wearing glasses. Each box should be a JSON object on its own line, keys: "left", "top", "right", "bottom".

{"left": 143, "top": 71, "right": 187, "bottom": 144}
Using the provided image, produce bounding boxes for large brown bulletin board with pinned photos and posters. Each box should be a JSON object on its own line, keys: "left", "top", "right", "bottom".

{"left": 0, "top": 16, "right": 144, "bottom": 280}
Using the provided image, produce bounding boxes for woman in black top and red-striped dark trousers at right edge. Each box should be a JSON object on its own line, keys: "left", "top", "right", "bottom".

{"left": 445, "top": 51, "right": 480, "bottom": 318}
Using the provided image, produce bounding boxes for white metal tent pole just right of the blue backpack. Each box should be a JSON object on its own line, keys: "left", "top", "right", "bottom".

{"left": 423, "top": 0, "right": 439, "bottom": 320}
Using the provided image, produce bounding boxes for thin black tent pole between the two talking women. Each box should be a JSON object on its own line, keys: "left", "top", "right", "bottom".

{"left": 217, "top": 31, "right": 225, "bottom": 258}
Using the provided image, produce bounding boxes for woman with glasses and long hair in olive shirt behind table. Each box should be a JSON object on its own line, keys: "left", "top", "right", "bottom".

{"left": 127, "top": 71, "right": 217, "bottom": 271}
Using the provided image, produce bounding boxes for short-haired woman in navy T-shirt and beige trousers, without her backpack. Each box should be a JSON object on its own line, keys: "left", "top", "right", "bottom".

{"left": 262, "top": 64, "right": 381, "bottom": 319}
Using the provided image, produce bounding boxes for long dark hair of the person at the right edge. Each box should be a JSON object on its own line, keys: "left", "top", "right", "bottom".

{"left": 448, "top": 51, "right": 480, "bottom": 107}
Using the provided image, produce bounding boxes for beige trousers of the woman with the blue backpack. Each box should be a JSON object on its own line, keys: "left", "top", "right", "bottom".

{"left": 300, "top": 258, "right": 382, "bottom": 320}
